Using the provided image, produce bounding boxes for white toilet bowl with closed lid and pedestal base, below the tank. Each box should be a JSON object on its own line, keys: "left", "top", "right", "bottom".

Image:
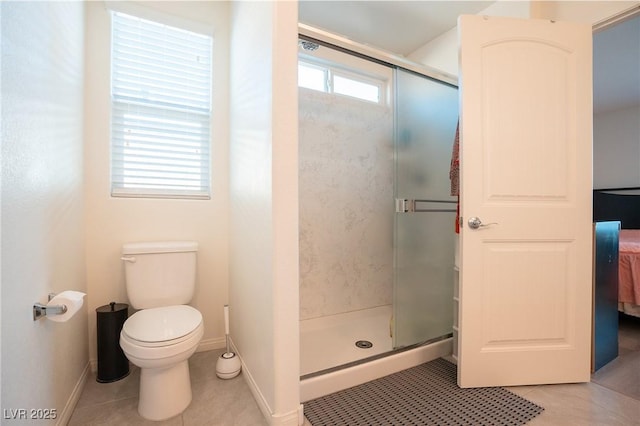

{"left": 120, "top": 305, "right": 204, "bottom": 420}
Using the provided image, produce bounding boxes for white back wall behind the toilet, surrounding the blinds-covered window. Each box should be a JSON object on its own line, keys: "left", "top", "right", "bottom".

{"left": 85, "top": 1, "right": 229, "bottom": 361}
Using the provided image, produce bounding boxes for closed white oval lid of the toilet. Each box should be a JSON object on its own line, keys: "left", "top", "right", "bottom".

{"left": 122, "top": 305, "right": 202, "bottom": 343}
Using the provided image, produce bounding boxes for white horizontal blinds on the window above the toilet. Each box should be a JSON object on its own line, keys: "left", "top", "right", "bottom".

{"left": 111, "top": 12, "right": 212, "bottom": 198}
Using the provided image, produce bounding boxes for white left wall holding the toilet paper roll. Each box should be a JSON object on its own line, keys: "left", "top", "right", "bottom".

{"left": 1, "top": 2, "right": 89, "bottom": 424}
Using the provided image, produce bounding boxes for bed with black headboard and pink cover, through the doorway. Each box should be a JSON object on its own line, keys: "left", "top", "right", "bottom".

{"left": 593, "top": 187, "right": 640, "bottom": 317}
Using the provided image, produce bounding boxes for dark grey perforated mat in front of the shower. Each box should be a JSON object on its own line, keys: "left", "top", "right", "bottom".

{"left": 304, "top": 358, "right": 544, "bottom": 426}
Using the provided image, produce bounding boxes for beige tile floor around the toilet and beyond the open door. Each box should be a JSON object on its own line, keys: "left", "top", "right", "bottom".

{"left": 69, "top": 319, "right": 640, "bottom": 426}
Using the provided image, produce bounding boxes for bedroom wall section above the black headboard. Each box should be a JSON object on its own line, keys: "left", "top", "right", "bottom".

{"left": 593, "top": 105, "right": 640, "bottom": 189}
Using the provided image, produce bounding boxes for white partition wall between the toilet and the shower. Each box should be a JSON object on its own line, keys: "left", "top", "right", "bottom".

{"left": 230, "top": 2, "right": 300, "bottom": 425}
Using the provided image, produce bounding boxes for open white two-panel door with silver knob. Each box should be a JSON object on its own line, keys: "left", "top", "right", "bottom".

{"left": 458, "top": 16, "right": 592, "bottom": 387}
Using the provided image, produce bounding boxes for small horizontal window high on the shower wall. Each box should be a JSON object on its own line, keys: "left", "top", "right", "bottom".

{"left": 298, "top": 60, "right": 386, "bottom": 104}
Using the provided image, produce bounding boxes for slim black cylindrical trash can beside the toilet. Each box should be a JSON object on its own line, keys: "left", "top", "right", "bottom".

{"left": 96, "top": 302, "right": 129, "bottom": 383}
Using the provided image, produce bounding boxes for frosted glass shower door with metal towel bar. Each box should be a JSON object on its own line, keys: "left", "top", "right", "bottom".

{"left": 393, "top": 70, "right": 458, "bottom": 348}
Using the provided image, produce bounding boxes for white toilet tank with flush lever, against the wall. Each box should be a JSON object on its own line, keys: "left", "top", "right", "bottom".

{"left": 122, "top": 241, "right": 198, "bottom": 309}
